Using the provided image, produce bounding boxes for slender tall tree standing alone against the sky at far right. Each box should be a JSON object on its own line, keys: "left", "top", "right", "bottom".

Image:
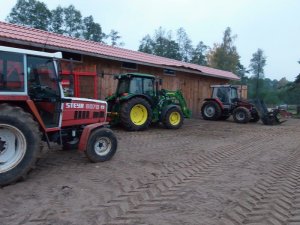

{"left": 249, "top": 48, "right": 266, "bottom": 97}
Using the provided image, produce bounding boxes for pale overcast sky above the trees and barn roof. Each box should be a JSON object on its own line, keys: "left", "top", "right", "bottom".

{"left": 0, "top": 0, "right": 300, "bottom": 81}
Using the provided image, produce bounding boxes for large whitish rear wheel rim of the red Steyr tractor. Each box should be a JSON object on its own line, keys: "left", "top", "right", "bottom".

{"left": 0, "top": 124, "right": 27, "bottom": 173}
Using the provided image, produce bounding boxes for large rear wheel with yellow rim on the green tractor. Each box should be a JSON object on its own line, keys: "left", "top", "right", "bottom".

{"left": 120, "top": 97, "right": 152, "bottom": 131}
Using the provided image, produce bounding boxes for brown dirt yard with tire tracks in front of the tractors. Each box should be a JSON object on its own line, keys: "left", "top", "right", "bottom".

{"left": 0, "top": 119, "right": 300, "bottom": 225}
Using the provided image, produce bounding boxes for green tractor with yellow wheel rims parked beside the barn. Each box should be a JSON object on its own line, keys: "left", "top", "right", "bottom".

{"left": 106, "top": 73, "right": 191, "bottom": 131}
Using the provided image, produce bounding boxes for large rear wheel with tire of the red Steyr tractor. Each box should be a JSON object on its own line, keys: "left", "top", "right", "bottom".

{"left": 0, "top": 104, "right": 41, "bottom": 186}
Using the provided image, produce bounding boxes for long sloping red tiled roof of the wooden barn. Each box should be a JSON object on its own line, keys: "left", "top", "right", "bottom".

{"left": 0, "top": 22, "right": 239, "bottom": 80}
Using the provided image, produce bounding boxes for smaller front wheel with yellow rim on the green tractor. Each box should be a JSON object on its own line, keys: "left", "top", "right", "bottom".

{"left": 162, "top": 107, "right": 184, "bottom": 129}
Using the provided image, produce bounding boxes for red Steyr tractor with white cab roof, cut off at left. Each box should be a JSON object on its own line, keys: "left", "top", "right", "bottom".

{"left": 0, "top": 46, "right": 117, "bottom": 186}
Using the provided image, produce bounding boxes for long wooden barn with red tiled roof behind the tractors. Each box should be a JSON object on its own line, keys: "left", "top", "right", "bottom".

{"left": 0, "top": 22, "right": 240, "bottom": 117}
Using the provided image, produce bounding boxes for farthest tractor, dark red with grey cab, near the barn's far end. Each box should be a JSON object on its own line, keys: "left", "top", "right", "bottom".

{"left": 201, "top": 85, "right": 260, "bottom": 123}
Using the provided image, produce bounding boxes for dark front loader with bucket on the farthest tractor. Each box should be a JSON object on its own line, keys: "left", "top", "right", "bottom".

{"left": 253, "top": 99, "right": 286, "bottom": 125}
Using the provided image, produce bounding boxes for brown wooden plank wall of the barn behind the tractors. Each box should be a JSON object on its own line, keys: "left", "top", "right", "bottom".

{"left": 61, "top": 57, "right": 228, "bottom": 118}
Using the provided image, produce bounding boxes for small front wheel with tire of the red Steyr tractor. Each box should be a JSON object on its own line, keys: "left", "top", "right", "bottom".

{"left": 85, "top": 128, "right": 118, "bottom": 163}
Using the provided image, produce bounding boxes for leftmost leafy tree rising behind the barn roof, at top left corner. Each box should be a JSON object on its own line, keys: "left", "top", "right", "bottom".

{"left": 6, "top": 0, "right": 51, "bottom": 30}
